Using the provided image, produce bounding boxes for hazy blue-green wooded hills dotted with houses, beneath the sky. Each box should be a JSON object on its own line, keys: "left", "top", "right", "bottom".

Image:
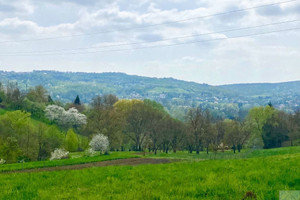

{"left": 0, "top": 71, "right": 300, "bottom": 118}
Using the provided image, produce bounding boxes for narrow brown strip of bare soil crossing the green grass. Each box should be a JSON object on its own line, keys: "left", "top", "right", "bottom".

{"left": 2, "top": 158, "right": 172, "bottom": 174}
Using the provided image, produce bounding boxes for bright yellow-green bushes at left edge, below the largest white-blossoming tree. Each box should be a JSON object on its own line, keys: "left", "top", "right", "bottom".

{"left": 0, "top": 110, "right": 64, "bottom": 162}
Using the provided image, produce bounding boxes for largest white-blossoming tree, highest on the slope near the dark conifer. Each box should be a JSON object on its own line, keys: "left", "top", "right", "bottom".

{"left": 45, "top": 105, "right": 87, "bottom": 128}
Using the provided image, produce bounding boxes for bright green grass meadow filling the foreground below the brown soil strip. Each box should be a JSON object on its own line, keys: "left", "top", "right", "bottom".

{"left": 0, "top": 147, "right": 300, "bottom": 200}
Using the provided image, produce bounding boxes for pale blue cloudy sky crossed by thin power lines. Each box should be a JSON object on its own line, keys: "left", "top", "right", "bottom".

{"left": 0, "top": 0, "right": 300, "bottom": 85}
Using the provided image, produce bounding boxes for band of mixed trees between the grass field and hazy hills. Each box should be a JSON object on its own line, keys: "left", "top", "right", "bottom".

{"left": 0, "top": 83, "right": 300, "bottom": 162}
